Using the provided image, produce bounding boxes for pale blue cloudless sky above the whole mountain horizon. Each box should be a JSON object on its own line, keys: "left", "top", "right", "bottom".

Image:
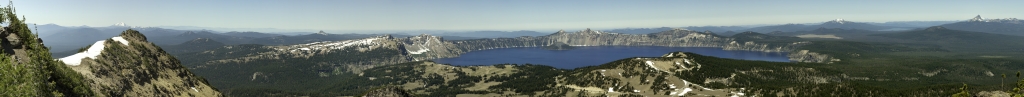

{"left": 3, "top": 0, "right": 1024, "bottom": 31}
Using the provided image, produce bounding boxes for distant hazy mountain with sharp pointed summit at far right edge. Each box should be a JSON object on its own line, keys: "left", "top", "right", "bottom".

{"left": 941, "top": 15, "right": 1024, "bottom": 36}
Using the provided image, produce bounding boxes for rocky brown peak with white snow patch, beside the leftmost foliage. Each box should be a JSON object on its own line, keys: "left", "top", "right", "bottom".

{"left": 60, "top": 30, "right": 221, "bottom": 97}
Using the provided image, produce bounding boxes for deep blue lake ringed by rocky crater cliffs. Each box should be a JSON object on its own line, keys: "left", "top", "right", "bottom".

{"left": 434, "top": 46, "right": 790, "bottom": 69}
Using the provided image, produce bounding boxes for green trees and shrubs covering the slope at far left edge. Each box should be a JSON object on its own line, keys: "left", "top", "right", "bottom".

{"left": 0, "top": 1, "right": 93, "bottom": 97}
